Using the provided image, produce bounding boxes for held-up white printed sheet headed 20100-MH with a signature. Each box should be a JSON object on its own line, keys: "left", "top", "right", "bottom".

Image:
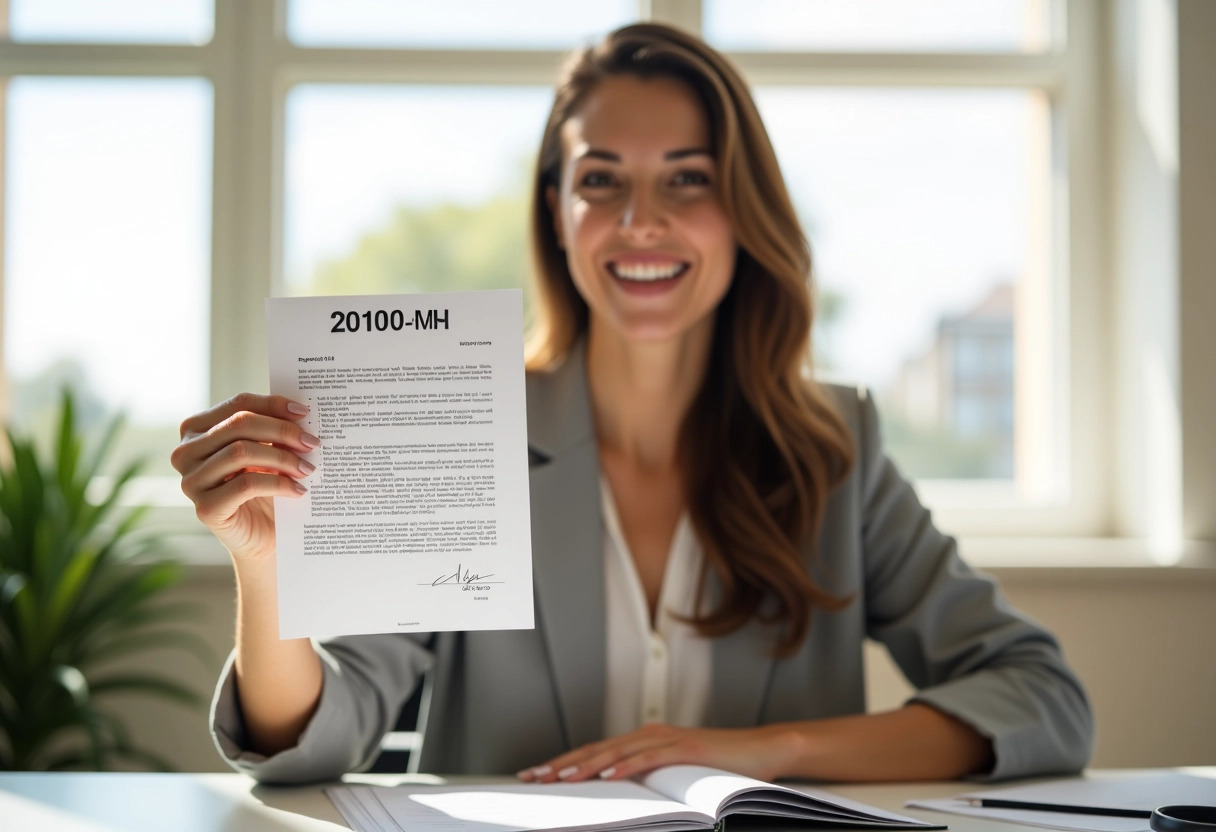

{"left": 266, "top": 289, "right": 534, "bottom": 639}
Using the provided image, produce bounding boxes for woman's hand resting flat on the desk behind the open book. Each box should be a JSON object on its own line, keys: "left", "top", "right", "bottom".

{"left": 517, "top": 724, "right": 796, "bottom": 783}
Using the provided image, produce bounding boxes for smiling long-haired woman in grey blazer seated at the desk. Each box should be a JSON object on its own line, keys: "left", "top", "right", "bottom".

{"left": 174, "top": 24, "right": 1092, "bottom": 782}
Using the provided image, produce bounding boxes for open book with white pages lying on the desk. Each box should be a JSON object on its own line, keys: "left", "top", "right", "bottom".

{"left": 325, "top": 765, "right": 945, "bottom": 832}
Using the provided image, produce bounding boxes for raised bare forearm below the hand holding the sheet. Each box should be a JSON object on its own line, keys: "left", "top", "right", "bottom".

{"left": 235, "top": 557, "right": 321, "bottom": 755}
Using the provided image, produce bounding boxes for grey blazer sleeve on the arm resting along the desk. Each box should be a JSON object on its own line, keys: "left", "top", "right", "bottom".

{"left": 857, "top": 392, "right": 1093, "bottom": 780}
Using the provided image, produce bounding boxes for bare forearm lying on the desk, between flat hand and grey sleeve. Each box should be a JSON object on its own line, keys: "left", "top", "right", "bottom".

{"left": 770, "top": 703, "right": 993, "bottom": 782}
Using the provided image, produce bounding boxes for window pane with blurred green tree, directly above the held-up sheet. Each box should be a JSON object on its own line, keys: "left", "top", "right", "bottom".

{"left": 283, "top": 84, "right": 551, "bottom": 301}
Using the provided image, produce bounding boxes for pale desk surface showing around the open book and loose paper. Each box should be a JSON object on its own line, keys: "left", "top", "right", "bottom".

{"left": 0, "top": 766, "right": 1216, "bottom": 832}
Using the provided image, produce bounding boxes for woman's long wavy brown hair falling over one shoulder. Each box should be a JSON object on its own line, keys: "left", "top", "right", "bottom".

{"left": 528, "top": 23, "right": 852, "bottom": 654}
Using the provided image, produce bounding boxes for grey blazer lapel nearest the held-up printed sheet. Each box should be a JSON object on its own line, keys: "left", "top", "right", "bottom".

{"left": 528, "top": 348, "right": 607, "bottom": 748}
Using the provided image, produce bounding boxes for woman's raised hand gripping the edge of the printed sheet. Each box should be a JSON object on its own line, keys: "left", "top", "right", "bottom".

{"left": 169, "top": 393, "right": 321, "bottom": 558}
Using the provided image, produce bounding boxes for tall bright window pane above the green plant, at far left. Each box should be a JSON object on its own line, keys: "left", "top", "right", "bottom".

{"left": 2, "top": 75, "right": 212, "bottom": 476}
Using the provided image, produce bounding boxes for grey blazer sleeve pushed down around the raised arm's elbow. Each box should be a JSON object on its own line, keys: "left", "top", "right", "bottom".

{"left": 210, "top": 634, "right": 434, "bottom": 783}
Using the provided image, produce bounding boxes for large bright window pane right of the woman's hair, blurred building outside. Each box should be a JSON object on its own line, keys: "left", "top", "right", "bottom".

{"left": 756, "top": 86, "right": 1053, "bottom": 486}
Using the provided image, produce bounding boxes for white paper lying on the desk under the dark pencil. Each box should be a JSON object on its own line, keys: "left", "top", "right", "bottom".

{"left": 907, "top": 772, "right": 1216, "bottom": 832}
